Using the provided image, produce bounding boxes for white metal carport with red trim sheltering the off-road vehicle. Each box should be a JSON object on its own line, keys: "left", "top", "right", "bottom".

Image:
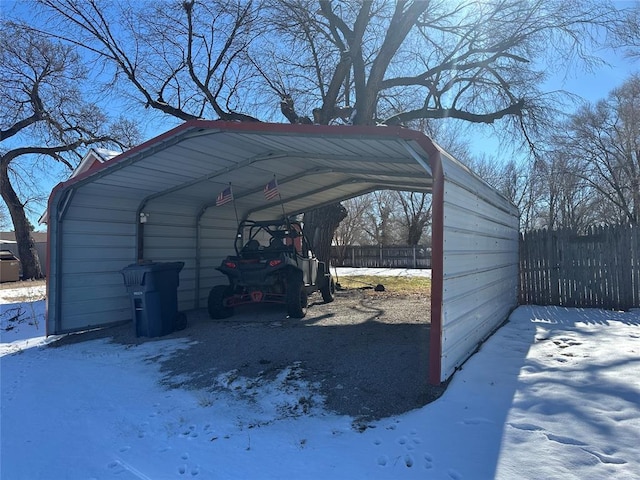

{"left": 47, "top": 120, "right": 518, "bottom": 384}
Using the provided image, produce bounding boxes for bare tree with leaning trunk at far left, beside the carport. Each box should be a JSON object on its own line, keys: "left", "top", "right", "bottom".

{"left": 0, "top": 22, "right": 135, "bottom": 278}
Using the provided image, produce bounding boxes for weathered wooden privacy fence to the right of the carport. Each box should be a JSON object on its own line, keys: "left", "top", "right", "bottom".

{"left": 520, "top": 225, "right": 640, "bottom": 310}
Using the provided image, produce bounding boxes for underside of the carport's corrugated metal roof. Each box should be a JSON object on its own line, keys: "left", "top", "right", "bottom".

{"left": 60, "top": 121, "right": 432, "bottom": 223}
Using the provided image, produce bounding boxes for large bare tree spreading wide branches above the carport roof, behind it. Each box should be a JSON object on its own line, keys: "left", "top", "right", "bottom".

{"left": 32, "top": 0, "right": 628, "bottom": 253}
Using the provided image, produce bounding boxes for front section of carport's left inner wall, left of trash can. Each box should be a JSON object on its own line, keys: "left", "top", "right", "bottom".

{"left": 47, "top": 183, "right": 136, "bottom": 334}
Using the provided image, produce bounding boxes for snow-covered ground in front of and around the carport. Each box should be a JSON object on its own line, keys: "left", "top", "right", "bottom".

{"left": 0, "top": 274, "right": 640, "bottom": 480}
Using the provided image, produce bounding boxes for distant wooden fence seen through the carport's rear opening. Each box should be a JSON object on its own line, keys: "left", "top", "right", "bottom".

{"left": 331, "top": 245, "right": 431, "bottom": 268}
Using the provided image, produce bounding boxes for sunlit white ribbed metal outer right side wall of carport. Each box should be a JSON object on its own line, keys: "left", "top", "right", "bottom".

{"left": 441, "top": 156, "right": 519, "bottom": 381}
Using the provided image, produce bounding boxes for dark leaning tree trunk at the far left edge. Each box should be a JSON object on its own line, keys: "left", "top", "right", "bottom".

{"left": 0, "top": 162, "right": 44, "bottom": 280}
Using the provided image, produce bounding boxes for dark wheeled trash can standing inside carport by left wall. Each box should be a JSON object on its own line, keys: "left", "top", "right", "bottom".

{"left": 121, "top": 262, "right": 186, "bottom": 337}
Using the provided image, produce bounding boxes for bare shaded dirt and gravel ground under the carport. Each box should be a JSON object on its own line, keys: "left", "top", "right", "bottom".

{"left": 51, "top": 289, "right": 444, "bottom": 420}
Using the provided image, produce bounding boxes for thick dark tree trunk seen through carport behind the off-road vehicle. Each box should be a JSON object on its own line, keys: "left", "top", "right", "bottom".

{"left": 304, "top": 203, "right": 347, "bottom": 265}
